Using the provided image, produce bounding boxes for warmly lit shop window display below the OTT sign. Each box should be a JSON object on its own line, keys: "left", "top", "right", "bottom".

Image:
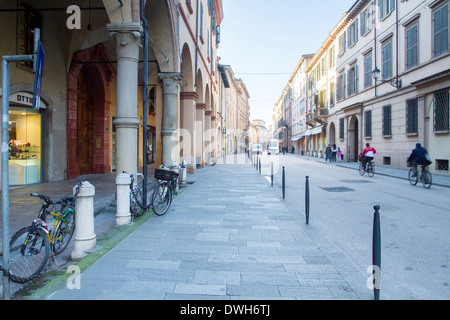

{"left": 9, "top": 106, "right": 41, "bottom": 185}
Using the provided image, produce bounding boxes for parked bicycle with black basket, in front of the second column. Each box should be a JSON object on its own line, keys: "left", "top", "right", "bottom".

{"left": 151, "top": 165, "right": 180, "bottom": 216}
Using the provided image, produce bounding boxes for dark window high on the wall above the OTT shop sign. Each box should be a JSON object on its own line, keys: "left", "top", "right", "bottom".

{"left": 17, "top": 4, "right": 42, "bottom": 68}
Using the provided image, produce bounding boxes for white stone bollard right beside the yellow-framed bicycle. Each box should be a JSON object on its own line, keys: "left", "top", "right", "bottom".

{"left": 71, "top": 181, "right": 97, "bottom": 260}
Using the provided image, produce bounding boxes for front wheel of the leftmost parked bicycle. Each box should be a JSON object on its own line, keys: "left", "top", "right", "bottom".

{"left": 9, "top": 226, "right": 50, "bottom": 282}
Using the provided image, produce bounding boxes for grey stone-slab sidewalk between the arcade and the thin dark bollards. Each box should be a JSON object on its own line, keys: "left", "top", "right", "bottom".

{"left": 32, "top": 156, "right": 373, "bottom": 300}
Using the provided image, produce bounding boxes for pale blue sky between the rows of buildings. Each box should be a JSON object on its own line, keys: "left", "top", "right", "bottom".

{"left": 218, "top": 0, "right": 356, "bottom": 126}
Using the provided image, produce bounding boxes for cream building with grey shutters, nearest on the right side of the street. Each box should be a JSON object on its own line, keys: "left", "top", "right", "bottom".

{"left": 334, "top": 0, "right": 450, "bottom": 174}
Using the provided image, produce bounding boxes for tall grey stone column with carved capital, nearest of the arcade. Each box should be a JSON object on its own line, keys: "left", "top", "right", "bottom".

{"left": 107, "top": 23, "right": 142, "bottom": 174}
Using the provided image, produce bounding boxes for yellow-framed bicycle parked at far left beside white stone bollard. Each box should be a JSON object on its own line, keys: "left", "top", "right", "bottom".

{"left": 4, "top": 180, "right": 83, "bottom": 283}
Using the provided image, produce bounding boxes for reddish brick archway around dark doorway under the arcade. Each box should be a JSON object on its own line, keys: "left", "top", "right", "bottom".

{"left": 66, "top": 44, "right": 115, "bottom": 179}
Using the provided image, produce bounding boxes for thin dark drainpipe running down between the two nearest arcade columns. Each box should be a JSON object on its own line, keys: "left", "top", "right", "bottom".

{"left": 140, "top": 0, "right": 148, "bottom": 207}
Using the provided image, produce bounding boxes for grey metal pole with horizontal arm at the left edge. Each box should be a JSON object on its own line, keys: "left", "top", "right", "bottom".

{"left": 1, "top": 55, "right": 33, "bottom": 300}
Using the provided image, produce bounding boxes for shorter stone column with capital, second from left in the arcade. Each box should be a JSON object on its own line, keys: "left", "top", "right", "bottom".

{"left": 158, "top": 72, "right": 181, "bottom": 164}
